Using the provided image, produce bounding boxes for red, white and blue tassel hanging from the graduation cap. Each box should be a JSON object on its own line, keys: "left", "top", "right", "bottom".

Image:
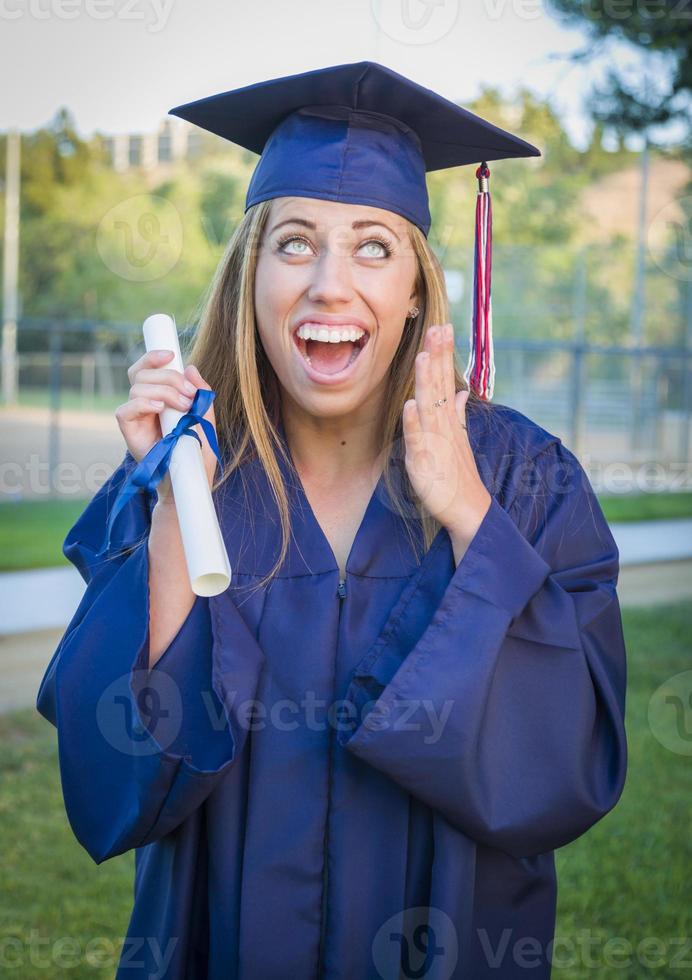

{"left": 464, "top": 160, "right": 495, "bottom": 401}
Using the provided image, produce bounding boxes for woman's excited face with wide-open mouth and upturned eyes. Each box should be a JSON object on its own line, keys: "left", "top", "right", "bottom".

{"left": 255, "top": 197, "right": 417, "bottom": 418}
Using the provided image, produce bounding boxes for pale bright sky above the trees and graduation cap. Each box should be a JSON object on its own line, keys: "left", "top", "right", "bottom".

{"left": 0, "top": 0, "right": 664, "bottom": 147}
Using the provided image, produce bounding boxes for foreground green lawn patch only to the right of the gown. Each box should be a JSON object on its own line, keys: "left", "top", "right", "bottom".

{"left": 554, "top": 602, "right": 692, "bottom": 980}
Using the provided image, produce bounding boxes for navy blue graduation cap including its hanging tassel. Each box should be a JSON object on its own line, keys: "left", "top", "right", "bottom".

{"left": 169, "top": 61, "right": 541, "bottom": 399}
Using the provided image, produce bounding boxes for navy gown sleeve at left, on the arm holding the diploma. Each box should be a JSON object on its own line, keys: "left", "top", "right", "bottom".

{"left": 36, "top": 452, "right": 263, "bottom": 864}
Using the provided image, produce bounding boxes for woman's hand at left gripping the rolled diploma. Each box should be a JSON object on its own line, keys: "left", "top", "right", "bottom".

{"left": 115, "top": 350, "right": 218, "bottom": 500}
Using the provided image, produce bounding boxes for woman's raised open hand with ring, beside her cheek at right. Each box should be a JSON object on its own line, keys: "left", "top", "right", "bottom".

{"left": 403, "top": 323, "right": 492, "bottom": 551}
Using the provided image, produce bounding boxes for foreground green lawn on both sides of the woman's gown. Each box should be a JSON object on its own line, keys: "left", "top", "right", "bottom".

{"left": 0, "top": 603, "right": 692, "bottom": 980}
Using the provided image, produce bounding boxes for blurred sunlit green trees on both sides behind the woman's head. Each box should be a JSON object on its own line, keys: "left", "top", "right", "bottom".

{"left": 0, "top": 98, "right": 684, "bottom": 350}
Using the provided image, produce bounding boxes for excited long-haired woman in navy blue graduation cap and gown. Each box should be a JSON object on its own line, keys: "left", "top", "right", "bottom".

{"left": 38, "top": 63, "right": 626, "bottom": 980}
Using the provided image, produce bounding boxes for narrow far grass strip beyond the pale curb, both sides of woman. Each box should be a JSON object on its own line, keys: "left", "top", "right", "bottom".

{"left": 5, "top": 493, "right": 692, "bottom": 571}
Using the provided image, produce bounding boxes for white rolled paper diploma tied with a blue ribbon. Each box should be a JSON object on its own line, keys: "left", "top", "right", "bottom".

{"left": 142, "top": 313, "right": 231, "bottom": 596}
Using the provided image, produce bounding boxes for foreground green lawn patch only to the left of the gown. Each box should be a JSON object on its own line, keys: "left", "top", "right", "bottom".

{"left": 0, "top": 709, "right": 134, "bottom": 980}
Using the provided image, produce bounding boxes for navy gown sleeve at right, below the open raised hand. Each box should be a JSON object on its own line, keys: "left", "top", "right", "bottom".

{"left": 337, "top": 441, "right": 627, "bottom": 857}
